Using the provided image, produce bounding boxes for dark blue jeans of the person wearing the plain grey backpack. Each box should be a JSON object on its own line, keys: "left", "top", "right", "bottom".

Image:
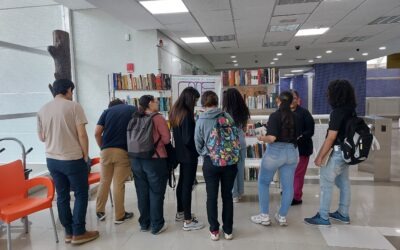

{"left": 132, "top": 158, "right": 168, "bottom": 234}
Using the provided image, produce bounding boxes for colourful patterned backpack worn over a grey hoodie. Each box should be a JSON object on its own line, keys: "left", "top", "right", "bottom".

{"left": 207, "top": 113, "right": 240, "bottom": 167}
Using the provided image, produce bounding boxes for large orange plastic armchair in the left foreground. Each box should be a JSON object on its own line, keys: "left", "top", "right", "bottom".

{"left": 0, "top": 160, "right": 58, "bottom": 250}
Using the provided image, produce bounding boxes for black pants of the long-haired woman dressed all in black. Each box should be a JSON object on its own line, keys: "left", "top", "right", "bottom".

{"left": 176, "top": 160, "right": 198, "bottom": 220}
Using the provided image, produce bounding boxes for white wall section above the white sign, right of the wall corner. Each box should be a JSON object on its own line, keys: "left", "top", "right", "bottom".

{"left": 157, "top": 31, "right": 214, "bottom": 75}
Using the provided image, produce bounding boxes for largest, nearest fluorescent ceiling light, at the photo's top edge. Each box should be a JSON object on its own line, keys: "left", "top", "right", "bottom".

{"left": 139, "top": 0, "right": 189, "bottom": 14}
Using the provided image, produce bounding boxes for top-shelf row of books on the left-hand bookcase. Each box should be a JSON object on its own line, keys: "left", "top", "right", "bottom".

{"left": 112, "top": 73, "right": 171, "bottom": 90}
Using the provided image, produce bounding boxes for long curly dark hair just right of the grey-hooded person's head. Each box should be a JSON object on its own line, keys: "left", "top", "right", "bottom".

{"left": 222, "top": 88, "right": 250, "bottom": 128}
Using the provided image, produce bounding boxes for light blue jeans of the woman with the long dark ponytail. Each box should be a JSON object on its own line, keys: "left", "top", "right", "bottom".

{"left": 258, "top": 142, "right": 299, "bottom": 216}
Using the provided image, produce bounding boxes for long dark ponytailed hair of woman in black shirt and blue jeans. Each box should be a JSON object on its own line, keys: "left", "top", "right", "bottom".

{"left": 279, "top": 91, "right": 296, "bottom": 138}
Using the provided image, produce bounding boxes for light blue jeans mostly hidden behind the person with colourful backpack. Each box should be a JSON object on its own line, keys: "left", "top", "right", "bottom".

{"left": 232, "top": 130, "right": 247, "bottom": 198}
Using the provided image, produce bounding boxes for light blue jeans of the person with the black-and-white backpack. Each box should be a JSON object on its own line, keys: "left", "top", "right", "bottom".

{"left": 319, "top": 150, "right": 350, "bottom": 220}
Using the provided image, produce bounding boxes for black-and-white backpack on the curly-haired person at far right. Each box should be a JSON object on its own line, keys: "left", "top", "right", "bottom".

{"left": 340, "top": 113, "right": 374, "bottom": 165}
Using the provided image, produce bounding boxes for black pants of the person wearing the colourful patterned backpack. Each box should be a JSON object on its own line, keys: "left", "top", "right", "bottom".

{"left": 203, "top": 157, "right": 237, "bottom": 234}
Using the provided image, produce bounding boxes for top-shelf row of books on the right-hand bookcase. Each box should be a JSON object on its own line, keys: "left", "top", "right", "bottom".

{"left": 221, "top": 68, "right": 279, "bottom": 87}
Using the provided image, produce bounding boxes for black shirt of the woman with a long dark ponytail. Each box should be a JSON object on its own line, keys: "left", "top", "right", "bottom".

{"left": 267, "top": 109, "right": 300, "bottom": 144}
